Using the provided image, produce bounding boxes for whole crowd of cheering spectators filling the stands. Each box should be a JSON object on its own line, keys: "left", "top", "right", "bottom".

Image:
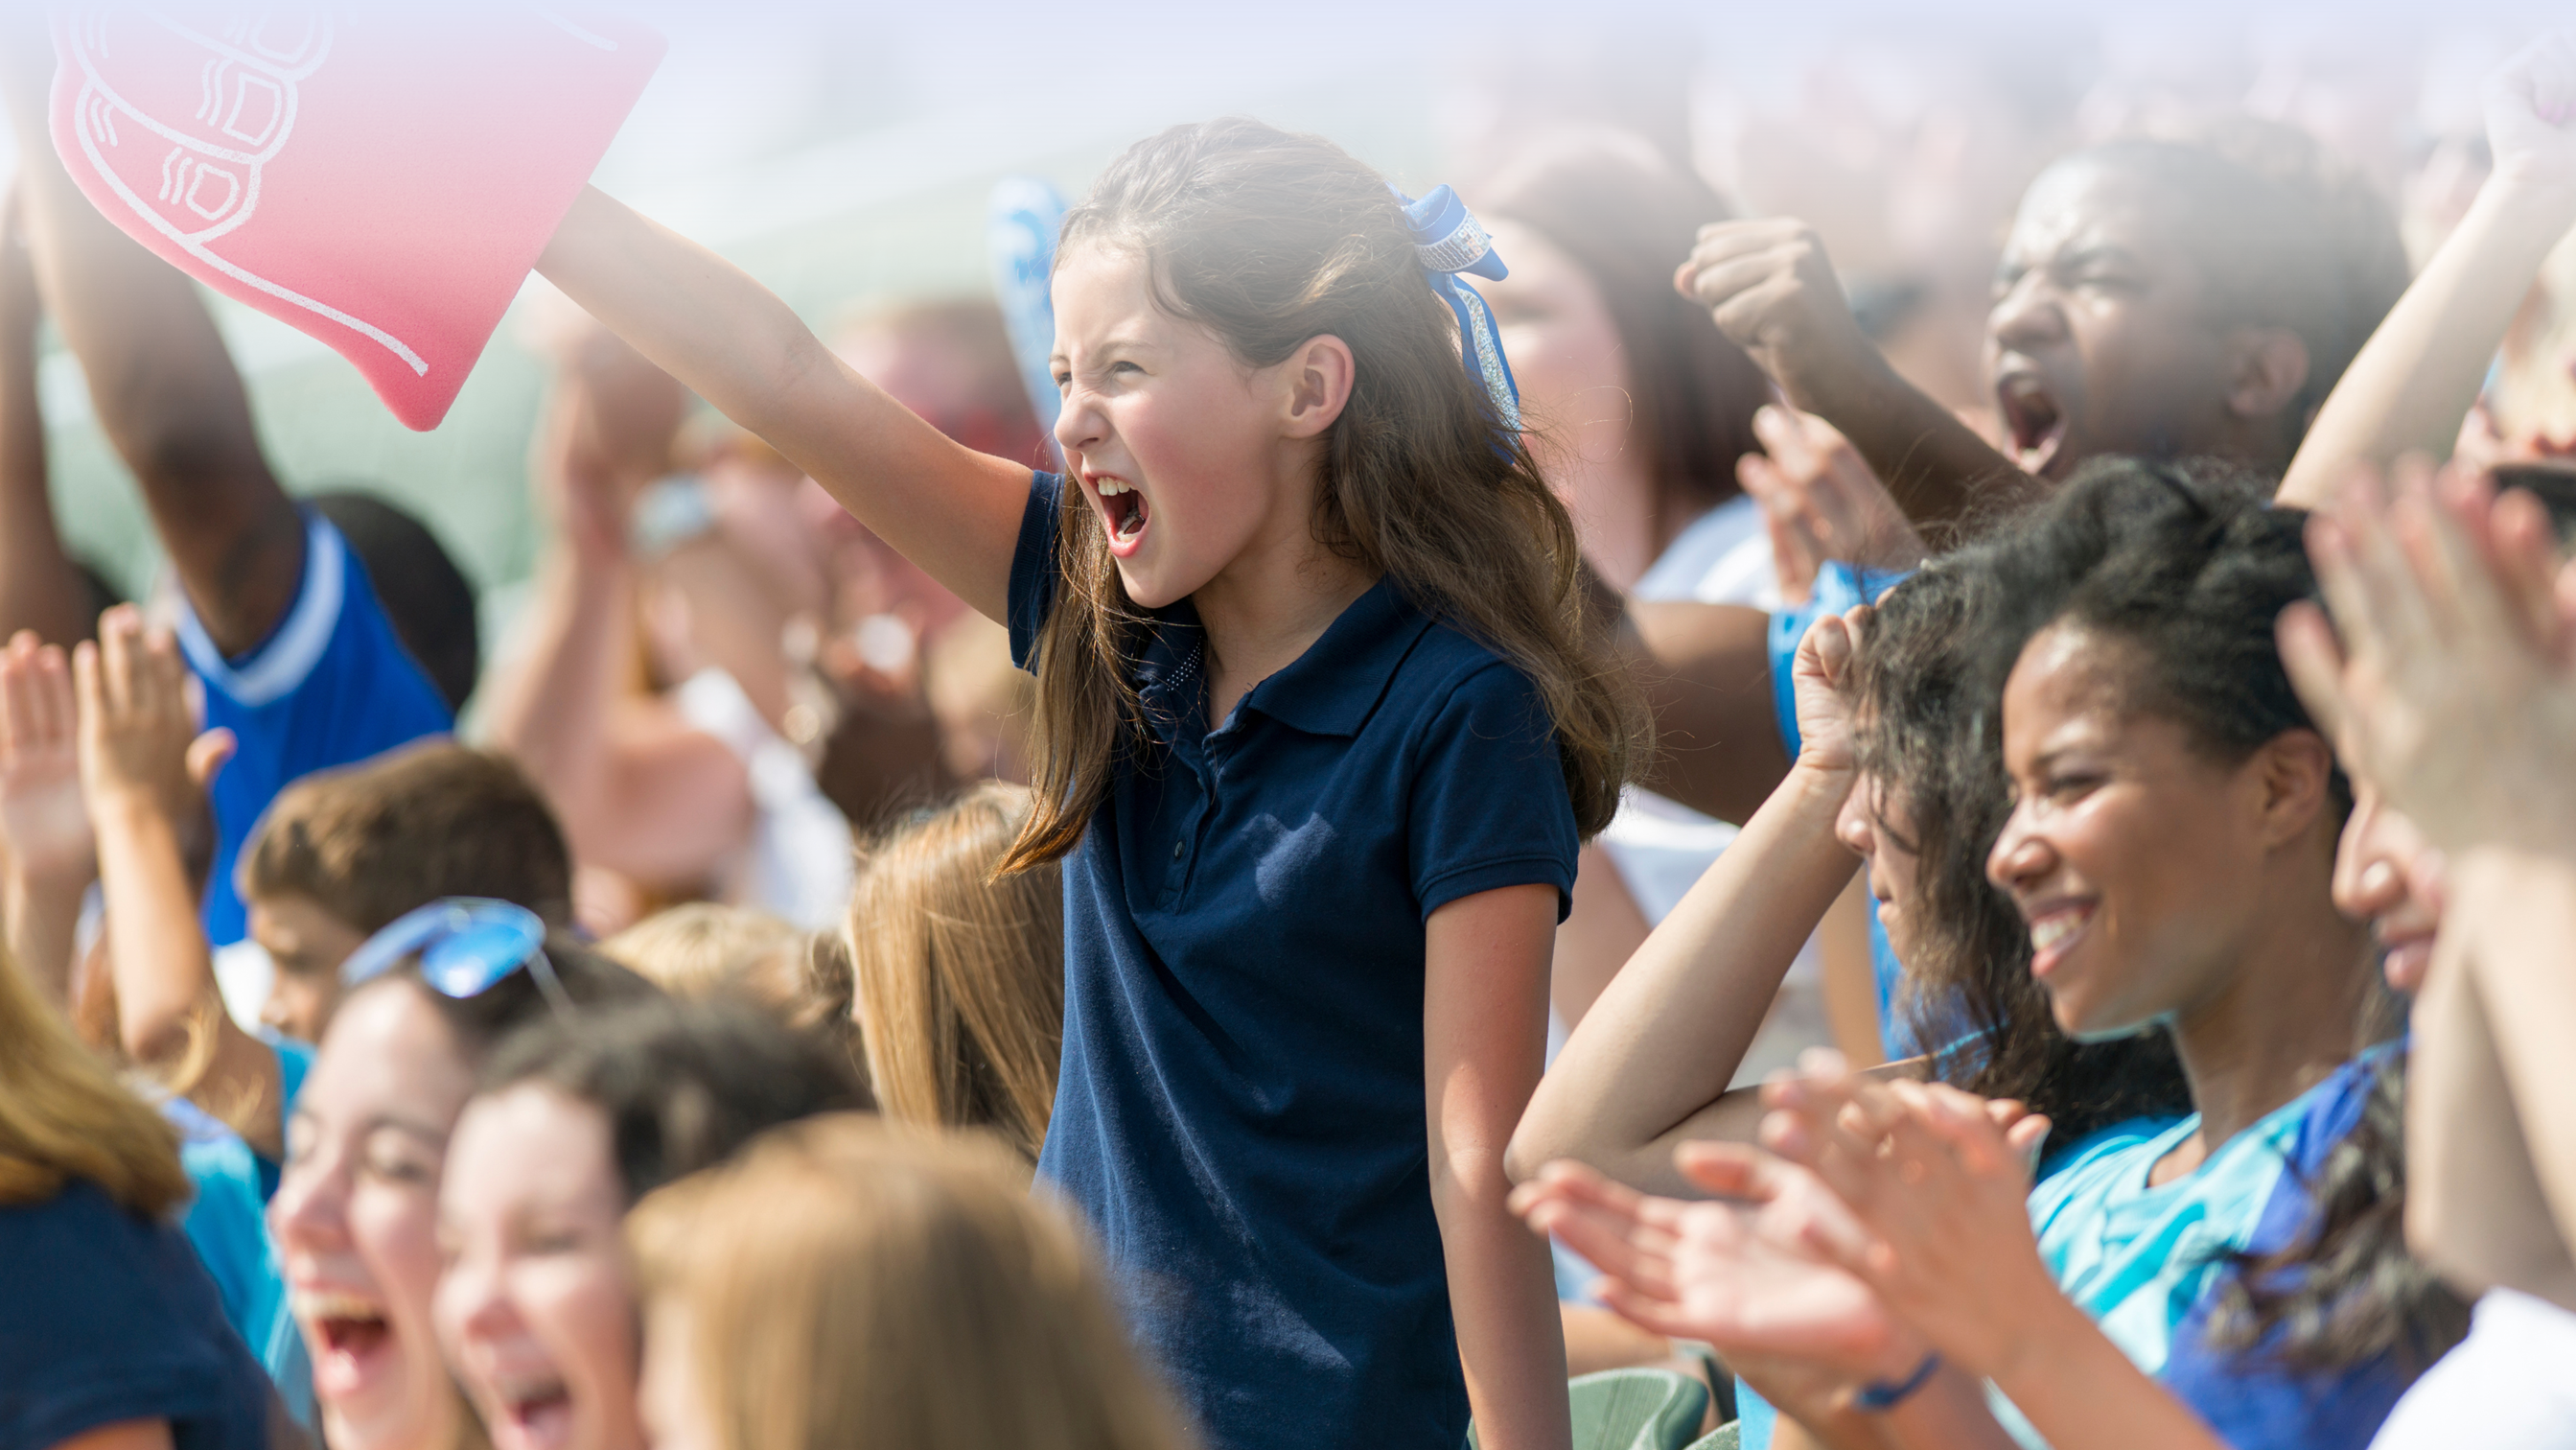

{"left": 0, "top": 8, "right": 2576, "bottom": 1450}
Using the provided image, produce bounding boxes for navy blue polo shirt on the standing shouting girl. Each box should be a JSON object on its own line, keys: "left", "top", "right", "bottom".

{"left": 1010, "top": 474, "right": 1576, "bottom": 1450}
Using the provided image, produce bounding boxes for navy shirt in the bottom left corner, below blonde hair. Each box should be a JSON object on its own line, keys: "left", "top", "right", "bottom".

{"left": 0, "top": 1180, "right": 267, "bottom": 1450}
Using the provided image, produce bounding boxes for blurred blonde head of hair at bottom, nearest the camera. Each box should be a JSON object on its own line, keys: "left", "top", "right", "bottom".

{"left": 626, "top": 1115, "right": 1185, "bottom": 1450}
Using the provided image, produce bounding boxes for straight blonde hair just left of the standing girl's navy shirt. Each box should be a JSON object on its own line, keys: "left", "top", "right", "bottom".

{"left": 850, "top": 783, "right": 1064, "bottom": 1161}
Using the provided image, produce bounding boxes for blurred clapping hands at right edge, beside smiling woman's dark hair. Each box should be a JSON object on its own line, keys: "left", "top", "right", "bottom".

{"left": 2280, "top": 458, "right": 2576, "bottom": 853}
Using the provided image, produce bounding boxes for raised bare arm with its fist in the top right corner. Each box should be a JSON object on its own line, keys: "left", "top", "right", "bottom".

{"left": 2280, "top": 34, "right": 2576, "bottom": 507}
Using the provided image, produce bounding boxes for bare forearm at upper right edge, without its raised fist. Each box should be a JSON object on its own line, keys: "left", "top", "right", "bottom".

{"left": 2280, "top": 175, "right": 2576, "bottom": 507}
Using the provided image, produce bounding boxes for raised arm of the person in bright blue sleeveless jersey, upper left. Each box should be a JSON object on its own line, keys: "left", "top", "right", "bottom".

{"left": 0, "top": 43, "right": 304, "bottom": 654}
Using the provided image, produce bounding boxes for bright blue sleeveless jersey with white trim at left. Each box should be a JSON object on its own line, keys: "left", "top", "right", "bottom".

{"left": 177, "top": 512, "right": 456, "bottom": 947}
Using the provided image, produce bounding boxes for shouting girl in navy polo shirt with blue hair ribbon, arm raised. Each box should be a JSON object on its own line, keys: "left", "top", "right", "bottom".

{"left": 541, "top": 121, "right": 1646, "bottom": 1450}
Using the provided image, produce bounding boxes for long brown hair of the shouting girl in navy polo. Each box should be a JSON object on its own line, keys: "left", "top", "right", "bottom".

{"left": 1002, "top": 119, "right": 1654, "bottom": 871}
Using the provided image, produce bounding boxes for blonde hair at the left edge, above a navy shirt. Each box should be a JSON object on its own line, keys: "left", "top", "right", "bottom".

{"left": 0, "top": 953, "right": 194, "bottom": 1218}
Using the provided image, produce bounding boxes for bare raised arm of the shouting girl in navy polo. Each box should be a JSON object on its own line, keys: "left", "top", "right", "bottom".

{"left": 536, "top": 188, "right": 1031, "bottom": 620}
